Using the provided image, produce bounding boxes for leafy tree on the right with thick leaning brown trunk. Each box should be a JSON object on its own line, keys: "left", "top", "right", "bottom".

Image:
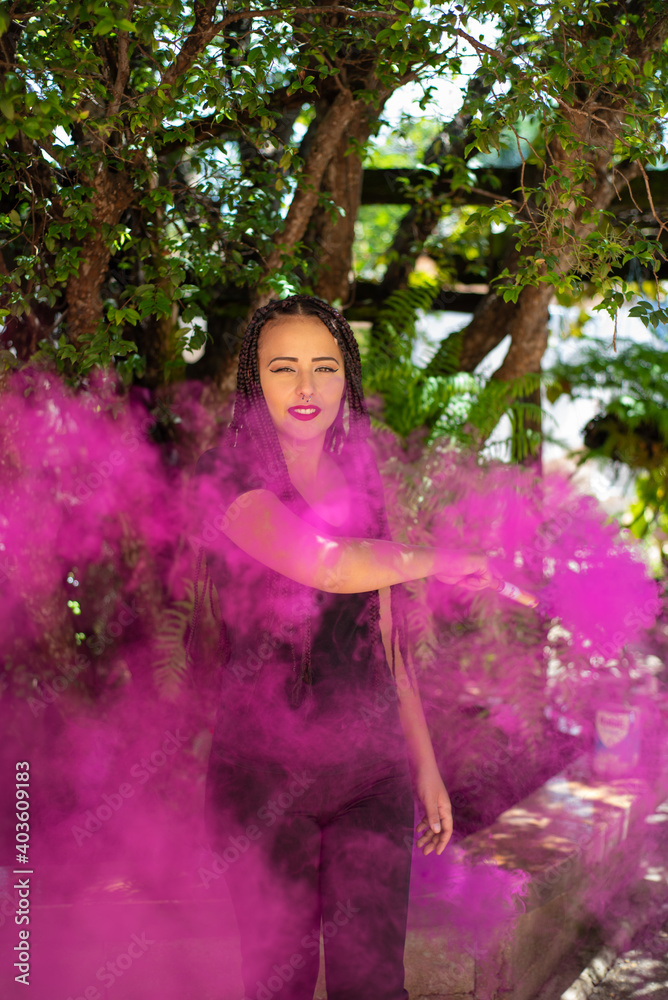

{"left": 358, "top": 3, "right": 668, "bottom": 458}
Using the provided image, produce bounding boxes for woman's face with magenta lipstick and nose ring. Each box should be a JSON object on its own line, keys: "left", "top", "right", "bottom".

{"left": 257, "top": 316, "right": 346, "bottom": 444}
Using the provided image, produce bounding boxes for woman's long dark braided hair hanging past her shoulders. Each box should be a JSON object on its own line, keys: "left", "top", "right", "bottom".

{"left": 191, "top": 295, "right": 413, "bottom": 707}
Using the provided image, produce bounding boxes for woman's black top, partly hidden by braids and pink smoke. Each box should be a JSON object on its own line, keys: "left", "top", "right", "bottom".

{"left": 196, "top": 448, "right": 406, "bottom": 770}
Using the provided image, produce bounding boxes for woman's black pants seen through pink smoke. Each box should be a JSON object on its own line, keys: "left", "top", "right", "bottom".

{"left": 206, "top": 747, "right": 414, "bottom": 1000}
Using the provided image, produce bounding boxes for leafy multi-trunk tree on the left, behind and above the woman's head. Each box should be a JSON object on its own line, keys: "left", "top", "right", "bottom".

{"left": 0, "top": 0, "right": 464, "bottom": 385}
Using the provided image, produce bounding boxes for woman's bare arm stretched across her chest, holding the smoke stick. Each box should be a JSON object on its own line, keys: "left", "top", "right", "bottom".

{"left": 207, "top": 489, "right": 492, "bottom": 594}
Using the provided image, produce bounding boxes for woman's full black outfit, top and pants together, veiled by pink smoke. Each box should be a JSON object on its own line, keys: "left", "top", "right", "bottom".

{"left": 197, "top": 449, "right": 414, "bottom": 1000}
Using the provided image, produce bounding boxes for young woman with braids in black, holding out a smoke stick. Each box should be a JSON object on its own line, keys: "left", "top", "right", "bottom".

{"left": 193, "top": 295, "right": 492, "bottom": 1000}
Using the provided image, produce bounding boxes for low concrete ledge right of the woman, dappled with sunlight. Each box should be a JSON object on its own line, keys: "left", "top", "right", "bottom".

{"left": 405, "top": 746, "right": 668, "bottom": 1000}
